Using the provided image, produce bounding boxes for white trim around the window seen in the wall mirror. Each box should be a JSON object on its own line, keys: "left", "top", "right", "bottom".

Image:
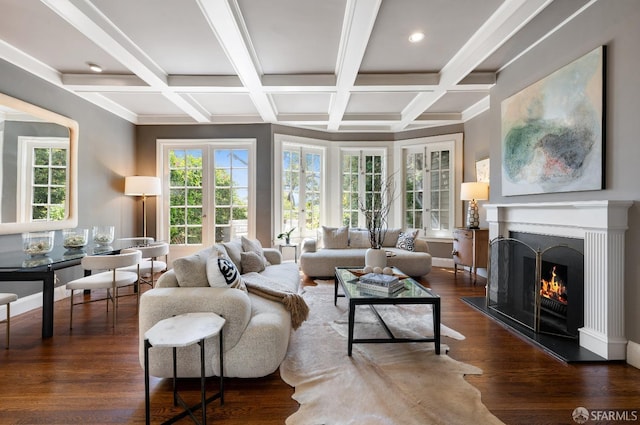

{"left": 16, "top": 136, "right": 71, "bottom": 223}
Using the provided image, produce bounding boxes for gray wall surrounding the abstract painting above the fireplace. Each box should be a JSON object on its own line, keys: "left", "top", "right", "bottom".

{"left": 465, "top": 0, "right": 640, "bottom": 342}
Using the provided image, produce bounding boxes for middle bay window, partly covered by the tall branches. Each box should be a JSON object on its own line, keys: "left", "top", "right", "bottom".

{"left": 341, "top": 149, "right": 385, "bottom": 228}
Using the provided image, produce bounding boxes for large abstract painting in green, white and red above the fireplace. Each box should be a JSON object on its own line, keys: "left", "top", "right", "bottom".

{"left": 501, "top": 46, "right": 605, "bottom": 196}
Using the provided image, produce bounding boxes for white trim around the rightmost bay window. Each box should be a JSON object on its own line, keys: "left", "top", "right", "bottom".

{"left": 393, "top": 133, "right": 463, "bottom": 238}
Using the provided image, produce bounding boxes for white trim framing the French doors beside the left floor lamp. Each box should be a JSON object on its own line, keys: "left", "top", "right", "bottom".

{"left": 156, "top": 138, "right": 257, "bottom": 245}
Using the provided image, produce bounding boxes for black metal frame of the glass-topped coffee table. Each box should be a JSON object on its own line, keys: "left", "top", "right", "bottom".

{"left": 333, "top": 271, "right": 440, "bottom": 357}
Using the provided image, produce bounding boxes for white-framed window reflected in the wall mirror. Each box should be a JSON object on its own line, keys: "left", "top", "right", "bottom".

{"left": 16, "top": 137, "right": 69, "bottom": 222}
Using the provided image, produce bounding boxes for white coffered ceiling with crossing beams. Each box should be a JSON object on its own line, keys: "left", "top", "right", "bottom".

{"left": 0, "top": 0, "right": 596, "bottom": 132}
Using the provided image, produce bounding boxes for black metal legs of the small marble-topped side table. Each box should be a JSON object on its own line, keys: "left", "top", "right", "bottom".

{"left": 144, "top": 329, "right": 224, "bottom": 425}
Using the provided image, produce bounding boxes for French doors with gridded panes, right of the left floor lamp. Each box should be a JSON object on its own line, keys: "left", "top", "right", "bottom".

{"left": 159, "top": 140, "right": 255, "bottom": 258}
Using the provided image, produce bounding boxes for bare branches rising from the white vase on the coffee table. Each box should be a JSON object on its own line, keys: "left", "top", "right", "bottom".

{"left": 358, "top": 175, "right": 395, "bottom": 263}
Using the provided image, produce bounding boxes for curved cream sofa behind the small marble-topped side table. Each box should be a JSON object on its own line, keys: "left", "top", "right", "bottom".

{"left": 139, "top": 238, "right": 300, "bottom": 378}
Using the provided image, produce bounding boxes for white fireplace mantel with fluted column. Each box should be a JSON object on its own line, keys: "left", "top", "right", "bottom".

{"left": 484, "top": 201, "right": 633, "bottom": 360}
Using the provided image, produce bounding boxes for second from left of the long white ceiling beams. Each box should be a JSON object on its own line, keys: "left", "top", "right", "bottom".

{"left": 197, "top": 0, "right": 277, "bottom": 122}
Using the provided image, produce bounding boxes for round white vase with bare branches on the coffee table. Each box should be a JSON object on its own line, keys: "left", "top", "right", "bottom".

{"left": 358, "top": 171, "right": 395, "bottom": 268}
